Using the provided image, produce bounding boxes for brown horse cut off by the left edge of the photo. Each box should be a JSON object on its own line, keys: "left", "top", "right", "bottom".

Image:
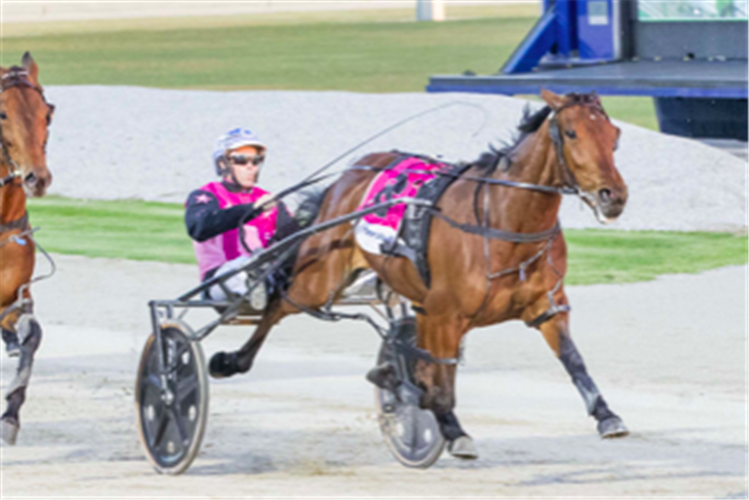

{"left": 0, "top": 52, "right": 54, "bottom": 444}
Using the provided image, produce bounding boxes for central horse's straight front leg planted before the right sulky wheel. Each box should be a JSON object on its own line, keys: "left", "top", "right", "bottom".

{"left": 415, "top": 314, "right": 478, "bottom": 459}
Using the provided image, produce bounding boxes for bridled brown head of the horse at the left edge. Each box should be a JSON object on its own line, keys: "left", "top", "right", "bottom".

{"left": 0, "top": 52, "right": 55, "bottom": 196}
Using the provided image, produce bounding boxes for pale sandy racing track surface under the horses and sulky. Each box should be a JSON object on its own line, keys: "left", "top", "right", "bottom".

{"left": 0, "top": 256, "right": 747, "bottom": 498}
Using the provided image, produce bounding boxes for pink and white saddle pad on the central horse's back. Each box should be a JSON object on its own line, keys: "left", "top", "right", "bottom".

{"left": 354, "top": 156, "right": 449, "bottom": 254}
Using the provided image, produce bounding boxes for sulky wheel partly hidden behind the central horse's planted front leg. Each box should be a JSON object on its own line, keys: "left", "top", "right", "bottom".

{"left": 375, "top": 318, "right": 445, "bottom": 469}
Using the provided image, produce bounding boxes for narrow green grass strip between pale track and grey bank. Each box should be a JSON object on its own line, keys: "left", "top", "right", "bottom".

{"left": 29, "top": 197, "right": 749, "bottom": 285}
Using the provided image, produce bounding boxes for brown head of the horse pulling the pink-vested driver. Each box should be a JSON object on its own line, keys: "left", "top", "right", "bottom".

{"left": 541, "top": 90, "right": 627, "bottom": 223}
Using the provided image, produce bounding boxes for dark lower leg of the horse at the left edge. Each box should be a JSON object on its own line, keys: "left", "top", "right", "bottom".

{"left": 0, "top": 314, "right": 42, "bottom": 445}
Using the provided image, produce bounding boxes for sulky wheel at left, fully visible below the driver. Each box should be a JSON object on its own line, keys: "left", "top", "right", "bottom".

{"left": 135, "top": 321, "right": 208, "bottom": 475}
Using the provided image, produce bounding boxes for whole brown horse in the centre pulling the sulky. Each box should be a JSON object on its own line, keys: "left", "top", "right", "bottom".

{"left": 211, "top": 91, "right": 627, "bottom": 458}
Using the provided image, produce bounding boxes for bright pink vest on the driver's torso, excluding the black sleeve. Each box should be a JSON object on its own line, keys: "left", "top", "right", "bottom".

{"left": 193, "top": 182, "right": 278, "bottom": 279}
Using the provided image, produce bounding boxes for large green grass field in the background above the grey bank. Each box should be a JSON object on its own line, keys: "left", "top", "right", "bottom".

{"left": 0, "top": 13, "right": 657, "bottom": 130}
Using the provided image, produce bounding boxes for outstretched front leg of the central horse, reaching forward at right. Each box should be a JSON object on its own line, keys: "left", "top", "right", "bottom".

{"left": 538, "top": 308, "right": 629, "bottom": 438}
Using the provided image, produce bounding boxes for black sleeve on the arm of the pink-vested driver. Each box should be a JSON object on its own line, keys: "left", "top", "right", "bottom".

{"left": 185, "top": 189, "right": 252, "bottom": 241}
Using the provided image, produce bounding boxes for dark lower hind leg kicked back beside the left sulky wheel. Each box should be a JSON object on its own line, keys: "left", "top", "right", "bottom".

{"left": 208, "top": 298, "right": 283, "bottom": 378}
